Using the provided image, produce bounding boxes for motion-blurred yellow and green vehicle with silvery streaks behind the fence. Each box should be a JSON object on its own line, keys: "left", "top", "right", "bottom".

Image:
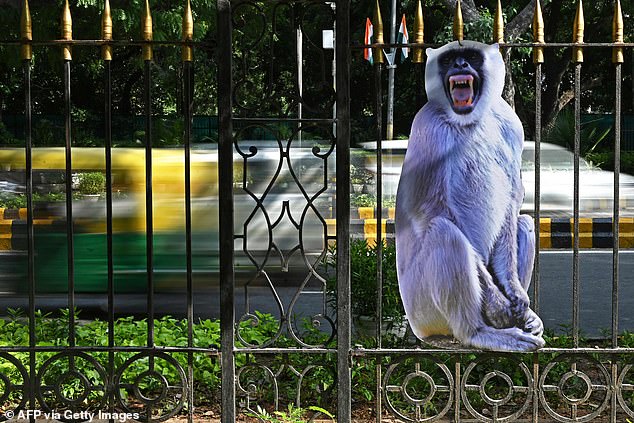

{"left": 0, "top": 147, "right": 334, "bottom": 293}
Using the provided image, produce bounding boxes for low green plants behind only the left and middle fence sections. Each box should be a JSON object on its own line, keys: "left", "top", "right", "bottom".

{"left": 0, "top": 309, "right": 336, "bottom": 414}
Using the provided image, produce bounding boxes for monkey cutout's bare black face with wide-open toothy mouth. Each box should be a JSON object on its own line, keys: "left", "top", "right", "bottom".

{"left": 438, "top": 49, "right": 484, "bottom": 114}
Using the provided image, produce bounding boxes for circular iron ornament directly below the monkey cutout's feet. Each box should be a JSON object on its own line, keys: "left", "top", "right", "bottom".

{"left": 461, "top": 355, "right": 533, "bottom": 422}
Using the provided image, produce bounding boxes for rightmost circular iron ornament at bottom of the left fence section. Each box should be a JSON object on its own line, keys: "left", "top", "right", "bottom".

{"left": 114, "top": 352, "right": 188, "bottom": 422}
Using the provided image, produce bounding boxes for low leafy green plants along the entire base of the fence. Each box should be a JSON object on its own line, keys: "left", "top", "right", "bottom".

{"left": 0, "top": 310, "right": 634, "bottom": 421}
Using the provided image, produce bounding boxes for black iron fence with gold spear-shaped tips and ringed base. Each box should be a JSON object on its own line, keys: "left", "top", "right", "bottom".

{"left": 0, "top": 0, "right": 634, "bottom": 422}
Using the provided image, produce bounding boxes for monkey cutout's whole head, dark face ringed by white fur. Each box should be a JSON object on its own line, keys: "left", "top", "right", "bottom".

{"left": 425, "top": 40, "right": 506, "bottom": 125}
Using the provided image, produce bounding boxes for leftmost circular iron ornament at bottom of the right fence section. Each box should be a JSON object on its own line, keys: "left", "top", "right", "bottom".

{"left": 383, "top": 357, "right": 454, "bottom": 422}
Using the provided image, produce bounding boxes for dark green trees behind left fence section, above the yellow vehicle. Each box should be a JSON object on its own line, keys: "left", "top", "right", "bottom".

{"left": 0, "top": 0, "right": 215, "bottom": 144}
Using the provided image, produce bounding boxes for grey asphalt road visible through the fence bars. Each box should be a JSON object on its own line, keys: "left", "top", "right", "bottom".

{"left": 0, "top": 250, "right": 634, "bottom": 337}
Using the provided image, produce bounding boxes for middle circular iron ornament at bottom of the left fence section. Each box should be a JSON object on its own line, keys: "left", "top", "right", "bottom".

{"left": 35, "top": 351, "right": 108, "bottom": 421}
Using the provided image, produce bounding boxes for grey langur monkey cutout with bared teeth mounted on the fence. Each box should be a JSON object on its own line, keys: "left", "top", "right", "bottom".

{"left": 396, "top": 41, "right": 544, "bottom": 351}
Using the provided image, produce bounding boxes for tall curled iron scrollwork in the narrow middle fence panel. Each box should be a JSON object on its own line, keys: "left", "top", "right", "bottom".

{"left": 234, "top": 123, "right": 336, "bottom": 348}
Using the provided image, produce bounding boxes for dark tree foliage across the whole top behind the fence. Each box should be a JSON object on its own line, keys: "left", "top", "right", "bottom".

{"left": 0, "top": 0, "right": 634, "bottom": 145}
